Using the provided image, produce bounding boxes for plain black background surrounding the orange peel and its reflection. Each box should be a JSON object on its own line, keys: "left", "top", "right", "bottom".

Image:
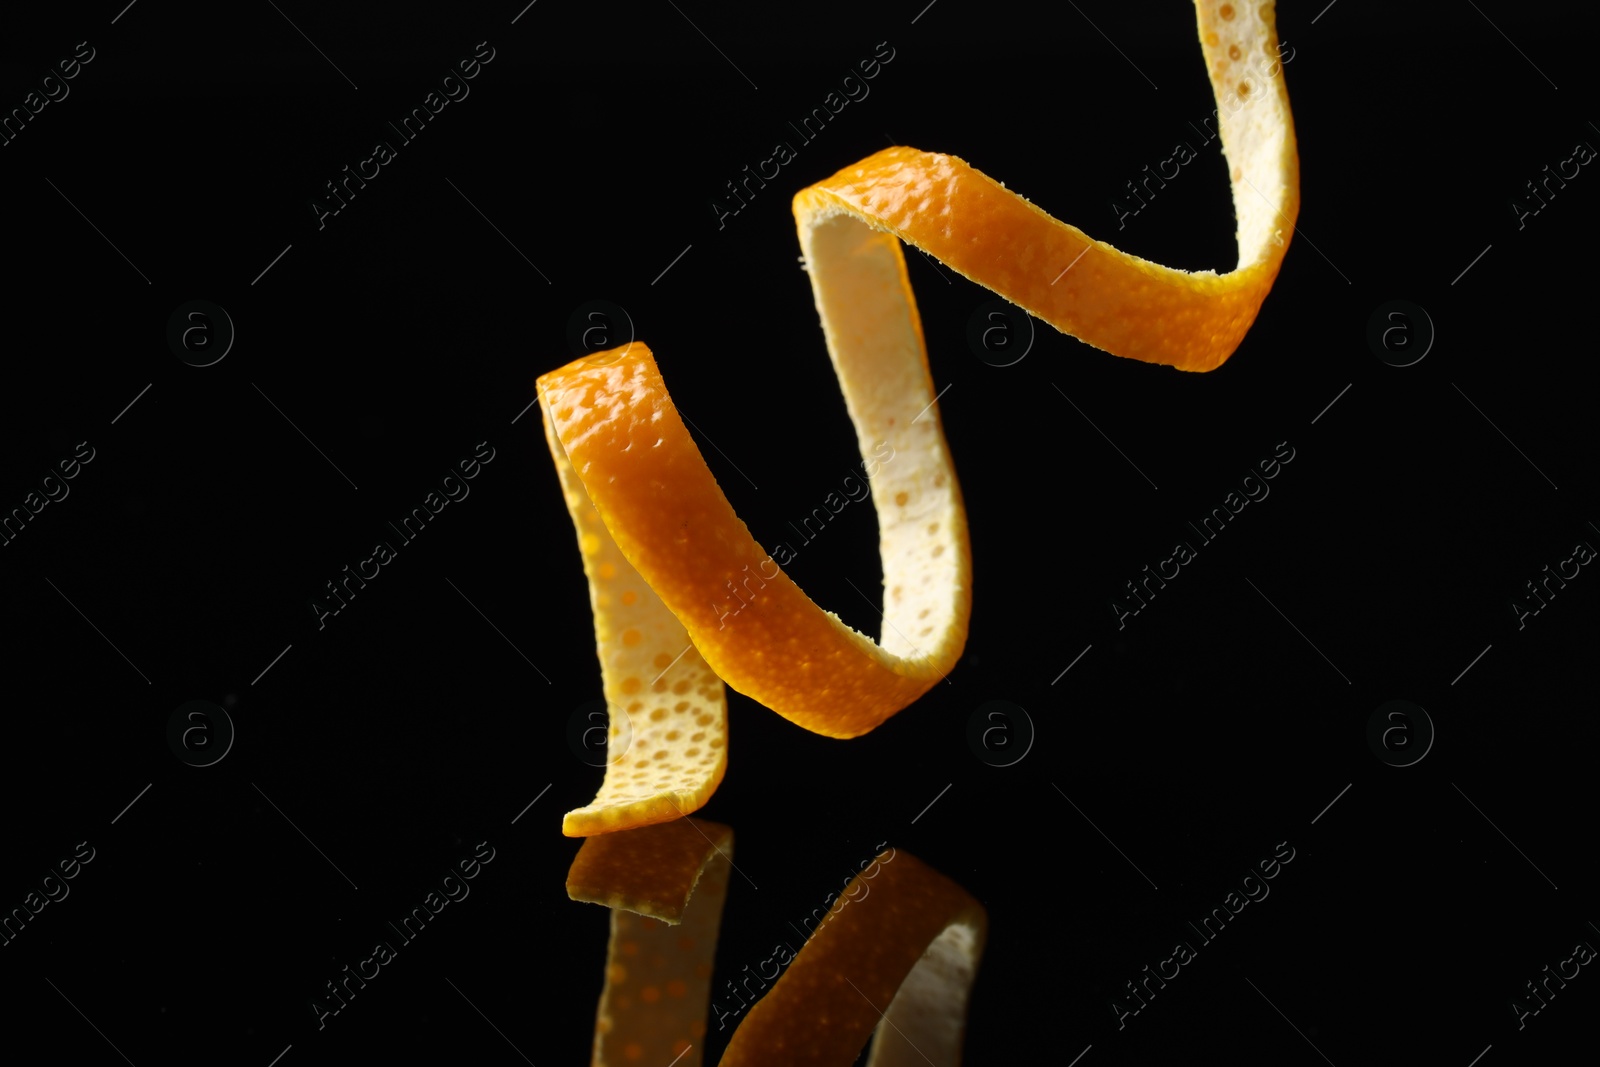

{"left": 0, "top": 0, "right": 1600, "bottom": 1067}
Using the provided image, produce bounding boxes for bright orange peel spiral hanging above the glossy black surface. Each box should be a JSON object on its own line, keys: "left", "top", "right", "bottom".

{"left": 539, "top": 0, "right": 1299, "bottom": 837}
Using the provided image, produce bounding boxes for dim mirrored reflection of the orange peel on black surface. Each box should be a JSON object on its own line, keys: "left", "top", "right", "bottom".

{"left": 568, "top": 819, "right": 987, "bottom": 1067}
